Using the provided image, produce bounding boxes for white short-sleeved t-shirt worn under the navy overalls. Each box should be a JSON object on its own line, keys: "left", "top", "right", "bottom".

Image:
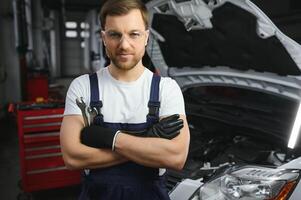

{"left": 64, "top": 68, "right": 185, "bottom": 121}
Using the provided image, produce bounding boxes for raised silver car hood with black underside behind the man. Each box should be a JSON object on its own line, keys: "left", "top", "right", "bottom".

{"left": 147, "top": 0, "right": 301, "bottom": 100}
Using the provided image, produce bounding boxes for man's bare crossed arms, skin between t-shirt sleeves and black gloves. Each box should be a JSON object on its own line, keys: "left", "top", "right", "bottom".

{"left": 60, "top": 115, "right": 190, "bottom": 169}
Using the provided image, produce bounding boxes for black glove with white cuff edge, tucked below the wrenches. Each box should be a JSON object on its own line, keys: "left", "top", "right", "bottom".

{"left": 80, "top": 125, "right": 118, "bottom": 149}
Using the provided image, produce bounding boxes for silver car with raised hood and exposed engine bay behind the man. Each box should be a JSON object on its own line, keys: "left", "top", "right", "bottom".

{"left": 146, "top": 0, "right": 301, "bottom": 200}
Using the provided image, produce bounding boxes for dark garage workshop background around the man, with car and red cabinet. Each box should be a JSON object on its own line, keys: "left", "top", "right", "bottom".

{"left": 0, "top": 0, "right": 301, "bottom": 200}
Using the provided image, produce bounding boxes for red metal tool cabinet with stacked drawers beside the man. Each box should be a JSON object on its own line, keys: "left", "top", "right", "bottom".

{"left": 17, "top": 108, "right": 80, "bottom": 192}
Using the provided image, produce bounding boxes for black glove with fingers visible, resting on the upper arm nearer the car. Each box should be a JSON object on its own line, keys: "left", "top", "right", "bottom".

{"left": 122, "top": 114, "right": 183, "bottom": 139}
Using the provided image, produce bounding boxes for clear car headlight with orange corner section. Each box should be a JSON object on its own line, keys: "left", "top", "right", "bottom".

{"left": 197, "top": 166, "right": 299, "bottom": 200}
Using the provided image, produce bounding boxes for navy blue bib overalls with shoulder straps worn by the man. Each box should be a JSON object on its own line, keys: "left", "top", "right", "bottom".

{"left": 79, "top": 73, "right": 170, "bottom": 200}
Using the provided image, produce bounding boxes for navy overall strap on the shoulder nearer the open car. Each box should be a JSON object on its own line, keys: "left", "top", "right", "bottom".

{"left": 146, "top": 74, "right": 161, "bottom": 125}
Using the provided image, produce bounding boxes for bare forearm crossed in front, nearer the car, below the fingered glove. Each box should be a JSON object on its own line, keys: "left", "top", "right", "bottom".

{"left": 115, "top": 121, "right": 189, "bottom": 169}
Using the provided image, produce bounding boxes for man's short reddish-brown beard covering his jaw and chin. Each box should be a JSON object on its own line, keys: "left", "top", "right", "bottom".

{"left": 106, "top": 49, "right": 144, "bottom": 71}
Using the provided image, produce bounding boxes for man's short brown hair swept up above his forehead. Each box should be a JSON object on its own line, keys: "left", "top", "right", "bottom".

{"left": 99, "top": 0, "right": 148, "bottom": 29}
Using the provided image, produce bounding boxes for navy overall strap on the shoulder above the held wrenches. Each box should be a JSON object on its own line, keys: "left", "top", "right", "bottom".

{"left": 89, "top": 73, "right": 103, "bottom": 124}
